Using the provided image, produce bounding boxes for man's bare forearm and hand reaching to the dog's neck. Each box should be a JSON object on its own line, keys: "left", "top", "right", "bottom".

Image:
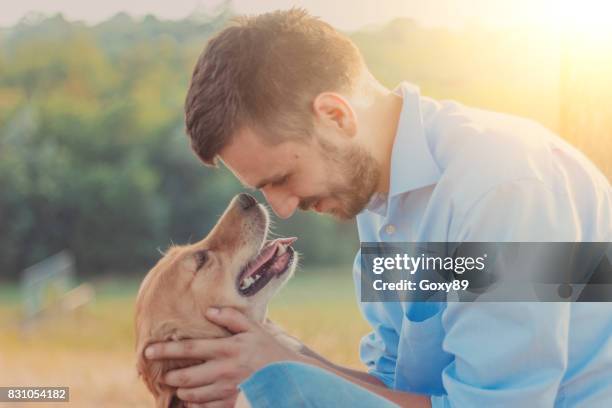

{"left": 145, "top": 307, "right": 430, "bottom": 408}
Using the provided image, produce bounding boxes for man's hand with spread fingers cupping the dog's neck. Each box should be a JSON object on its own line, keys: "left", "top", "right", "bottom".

{"left": 145, "top": 307, "right": 300, "bottom": 407}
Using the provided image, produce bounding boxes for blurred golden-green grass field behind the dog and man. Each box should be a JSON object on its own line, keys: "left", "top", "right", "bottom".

{"left": 0, "top": 268, "right": 368, "bottom": 407}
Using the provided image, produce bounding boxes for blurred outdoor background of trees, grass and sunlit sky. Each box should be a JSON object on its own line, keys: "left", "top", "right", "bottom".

{"left": 0, "top": 0, "right": 612, "bottom": 406}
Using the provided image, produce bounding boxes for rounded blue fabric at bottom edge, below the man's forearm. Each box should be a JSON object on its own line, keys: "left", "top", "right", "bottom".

{"left": 240, "top": 362, "right": 397, "bottom": 408}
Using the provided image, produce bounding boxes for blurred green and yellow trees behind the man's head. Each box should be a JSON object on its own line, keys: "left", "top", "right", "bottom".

{"left": 0, "top": 11, "right": 356, "bottom": 278}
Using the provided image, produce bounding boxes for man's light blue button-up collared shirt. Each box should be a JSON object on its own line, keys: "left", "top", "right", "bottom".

{"left": 354, "top": 83, "right": 612, "bottom": 407}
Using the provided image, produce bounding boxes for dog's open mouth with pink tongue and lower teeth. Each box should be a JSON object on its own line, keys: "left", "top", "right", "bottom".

{"left": 237, "top": 237, "right": 297, "bottom": 296}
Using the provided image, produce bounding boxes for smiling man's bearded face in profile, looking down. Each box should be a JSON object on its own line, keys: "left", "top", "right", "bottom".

{"left": 219, "top": 128, "right": 379, "bottom": 219}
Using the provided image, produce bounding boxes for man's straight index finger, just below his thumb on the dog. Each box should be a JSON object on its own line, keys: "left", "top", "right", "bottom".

{"left": 145, "top": 338, "right": 228, "bottom": 360}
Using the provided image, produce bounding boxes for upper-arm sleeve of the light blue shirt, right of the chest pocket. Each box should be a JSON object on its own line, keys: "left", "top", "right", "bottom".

{"left": 431, "top": 180, "right": 580, "bottom": 408}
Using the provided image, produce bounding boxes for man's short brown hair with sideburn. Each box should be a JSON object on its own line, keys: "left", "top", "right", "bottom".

{"left": 185, "top": 8, "right": 362, "bottom": 165}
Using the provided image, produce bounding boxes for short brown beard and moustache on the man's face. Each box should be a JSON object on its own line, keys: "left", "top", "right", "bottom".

{"left": 299, "top": 139, "right": 380, "bottom": 220}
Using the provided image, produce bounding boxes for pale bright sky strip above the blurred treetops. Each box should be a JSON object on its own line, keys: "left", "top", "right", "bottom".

{"left": 0, "top": 0, "right": 562, "bottom": 30}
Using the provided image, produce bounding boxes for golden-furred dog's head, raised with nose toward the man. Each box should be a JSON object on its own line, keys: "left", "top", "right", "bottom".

{"left": 135, "top": 194, "right": 298, "bottom": 408}
